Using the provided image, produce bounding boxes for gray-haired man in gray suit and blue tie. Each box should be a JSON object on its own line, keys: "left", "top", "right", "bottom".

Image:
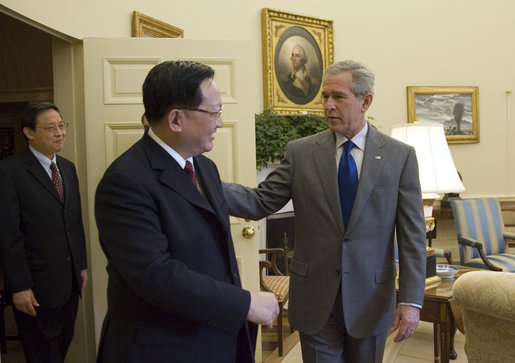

{"left": 224, "top": 61, "right": 426, "bottom": 362}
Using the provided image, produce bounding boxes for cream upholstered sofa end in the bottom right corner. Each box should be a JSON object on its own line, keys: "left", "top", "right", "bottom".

{"left": 453, "top": 271, "right": 515, "bottom": 363}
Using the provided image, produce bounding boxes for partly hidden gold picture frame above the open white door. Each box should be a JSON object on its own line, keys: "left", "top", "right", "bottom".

{"left": 132, "top": 11, "right": 184, "bottom": 38}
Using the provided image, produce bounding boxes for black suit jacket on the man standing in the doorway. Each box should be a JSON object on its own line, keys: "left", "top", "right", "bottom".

{"left": 0, "top": 148, "right": 87, "bottom": 307}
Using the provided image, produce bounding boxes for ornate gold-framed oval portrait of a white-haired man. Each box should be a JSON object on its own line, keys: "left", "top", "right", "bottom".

{"left": 261, "top": 8, "right": 334, "bottom": 114}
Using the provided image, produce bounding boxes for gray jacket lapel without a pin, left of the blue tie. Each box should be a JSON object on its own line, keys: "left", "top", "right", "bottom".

{"left": 313, "top": 131, "right": 345, "bottom": 234}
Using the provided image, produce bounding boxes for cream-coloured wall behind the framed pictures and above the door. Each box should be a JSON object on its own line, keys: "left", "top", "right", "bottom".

{"left": 1, "top": 0, "right": 515, "bottom": 197}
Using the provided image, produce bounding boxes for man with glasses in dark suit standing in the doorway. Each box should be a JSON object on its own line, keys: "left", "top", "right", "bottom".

{"left": 0, "top": 102, "right": 88, "bottom": 362}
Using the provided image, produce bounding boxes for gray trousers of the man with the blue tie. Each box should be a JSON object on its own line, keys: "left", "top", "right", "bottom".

{"left": 299, "top": 289, "right": 387, "bottom": 363}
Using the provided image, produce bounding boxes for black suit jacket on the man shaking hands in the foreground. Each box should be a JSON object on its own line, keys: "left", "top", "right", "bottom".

{"left": 95, "top": 134, "right": 256, "bottom": 363}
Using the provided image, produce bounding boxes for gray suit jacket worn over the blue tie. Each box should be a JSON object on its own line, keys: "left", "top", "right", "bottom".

{"left": 224, "top": 127, "right": 426, "bottom": 338}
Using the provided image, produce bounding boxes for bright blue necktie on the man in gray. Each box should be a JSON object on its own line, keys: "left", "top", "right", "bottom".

{"left": 338, "top": 140, "right": 358, "bottom": 228}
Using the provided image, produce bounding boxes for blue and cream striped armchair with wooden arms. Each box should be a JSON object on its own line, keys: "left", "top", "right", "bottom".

{"left": 452, "top": 198, "right": 515, "bottom": 272}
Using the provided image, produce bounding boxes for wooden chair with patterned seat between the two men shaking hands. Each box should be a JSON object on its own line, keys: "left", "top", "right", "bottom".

{"left": 259, "top": 248, "right": 290, "bottom": 356}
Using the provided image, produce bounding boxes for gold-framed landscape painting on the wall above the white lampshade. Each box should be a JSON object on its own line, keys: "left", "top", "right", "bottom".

{"left": 407, "top": 86, "right": 479, "bottom": 144}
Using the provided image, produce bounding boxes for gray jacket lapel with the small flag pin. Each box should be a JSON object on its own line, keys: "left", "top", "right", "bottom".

{"left": 347, "top": 126, "right": 386, "bottom": 228}
